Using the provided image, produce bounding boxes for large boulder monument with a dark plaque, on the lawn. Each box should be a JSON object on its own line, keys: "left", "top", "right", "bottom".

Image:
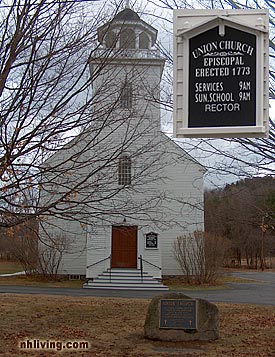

{"left": 144, "top": 293, "right": 219, "bottom": 341}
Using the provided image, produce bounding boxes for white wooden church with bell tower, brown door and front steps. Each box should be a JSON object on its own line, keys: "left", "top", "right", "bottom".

{"left": 41, "top": 7, "right": 205, "bottom": 289}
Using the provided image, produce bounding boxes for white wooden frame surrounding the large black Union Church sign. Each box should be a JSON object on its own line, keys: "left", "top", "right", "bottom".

{"left": 173, "top": 9, "right": 269, "bottom": 138}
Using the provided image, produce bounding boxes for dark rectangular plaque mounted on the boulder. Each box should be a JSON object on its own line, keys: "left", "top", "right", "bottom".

{"left": 159, "top": 299, "right": 197, "bottom": 330}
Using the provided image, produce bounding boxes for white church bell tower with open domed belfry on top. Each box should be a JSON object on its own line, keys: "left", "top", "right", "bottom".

{"left": 90, "top": 2, "right": 165, "bottom": 129}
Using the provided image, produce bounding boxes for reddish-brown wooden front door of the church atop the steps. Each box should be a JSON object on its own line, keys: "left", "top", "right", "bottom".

{"left": 111, "top": 226, "right": 138, "bottom": 268}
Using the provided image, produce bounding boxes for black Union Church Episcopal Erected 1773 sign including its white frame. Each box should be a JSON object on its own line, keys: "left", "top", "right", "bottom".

{"left": 174, "top": 10, "right": 269, "bottom": 137}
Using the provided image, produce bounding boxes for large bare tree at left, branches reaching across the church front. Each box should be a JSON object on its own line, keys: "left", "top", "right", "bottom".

{"left": 0, "top": 0, "right": 170, "bottom": 231}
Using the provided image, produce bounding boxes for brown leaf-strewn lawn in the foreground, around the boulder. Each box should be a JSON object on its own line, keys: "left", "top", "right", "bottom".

{"left": 0, "top": 294, "right": 275, "bottom": 357}
